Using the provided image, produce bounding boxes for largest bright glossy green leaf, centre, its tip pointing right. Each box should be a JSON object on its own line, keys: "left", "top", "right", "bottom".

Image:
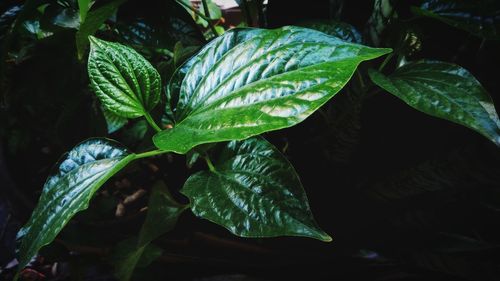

{"left": 153, "top": 26, "right": 390, "bottom": 154}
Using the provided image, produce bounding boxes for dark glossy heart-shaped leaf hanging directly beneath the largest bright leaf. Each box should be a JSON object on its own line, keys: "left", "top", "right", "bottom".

{"left": 181, "top": 137, "right": 331, "bottom": 241}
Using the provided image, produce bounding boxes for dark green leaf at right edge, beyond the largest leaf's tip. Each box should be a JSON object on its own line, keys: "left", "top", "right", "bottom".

{"left": 369, "top": 60, "right": 500, "bottom": 145}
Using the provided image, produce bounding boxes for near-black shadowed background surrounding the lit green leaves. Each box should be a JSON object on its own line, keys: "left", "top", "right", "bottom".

{"left": 0, "top": 0, "right": 500, "bottom": 280}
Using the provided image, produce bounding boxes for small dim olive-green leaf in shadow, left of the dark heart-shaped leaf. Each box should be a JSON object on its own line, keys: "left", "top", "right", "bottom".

{"left": 138, "top": 181, "right": 188, "bottom": 247}
